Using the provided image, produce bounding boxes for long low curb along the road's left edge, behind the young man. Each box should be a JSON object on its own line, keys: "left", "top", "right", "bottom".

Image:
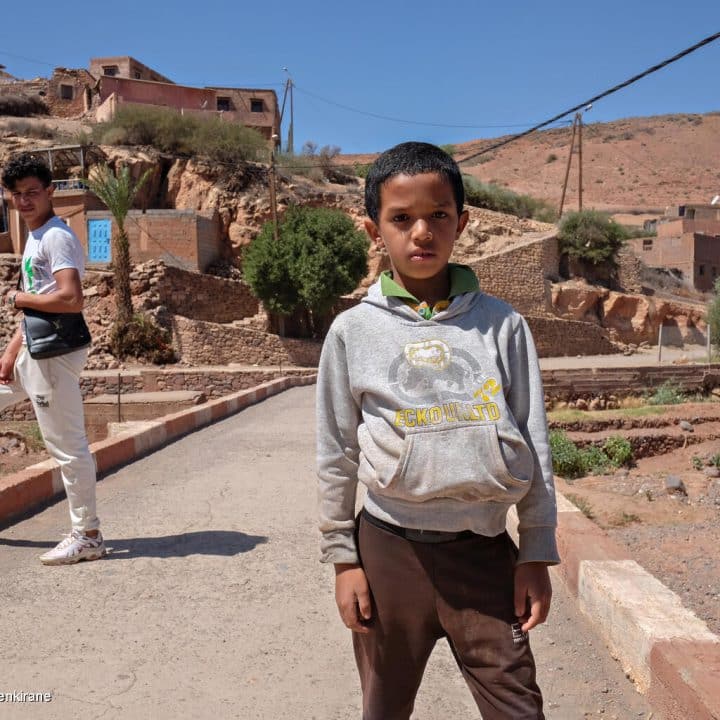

{"left": 0, "top": 375, "right": 317, "bottom": 525}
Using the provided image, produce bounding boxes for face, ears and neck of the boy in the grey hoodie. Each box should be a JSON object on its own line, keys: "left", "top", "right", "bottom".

{"left": 365, "top": 173, "right": 468, "bottom": 302}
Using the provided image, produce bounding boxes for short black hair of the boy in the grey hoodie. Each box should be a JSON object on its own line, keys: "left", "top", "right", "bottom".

{"left": 365, "top": 142, "right": 465, "bottom": 223}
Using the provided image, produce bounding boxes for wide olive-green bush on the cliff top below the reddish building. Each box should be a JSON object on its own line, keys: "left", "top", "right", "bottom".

{"left": 93, "top": 105, "right": 269, "bottom": 163}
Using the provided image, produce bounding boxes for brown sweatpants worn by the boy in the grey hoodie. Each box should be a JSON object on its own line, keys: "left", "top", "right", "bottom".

{"left": 353, "top": 516, "right": 545, "bottom": 720}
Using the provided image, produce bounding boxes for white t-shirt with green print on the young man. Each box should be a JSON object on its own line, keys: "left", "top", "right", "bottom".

{"left": 22, "top": 215, "right": 85, "bottom": 295}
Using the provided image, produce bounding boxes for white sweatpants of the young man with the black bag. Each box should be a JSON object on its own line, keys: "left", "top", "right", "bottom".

{"left": 15, "top": 347, "right": 100, "bottom": 532}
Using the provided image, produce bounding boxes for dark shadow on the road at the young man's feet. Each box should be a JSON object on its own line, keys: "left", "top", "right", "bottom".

{"left": 0, "top": 530, "right": 268, "bottom": 560}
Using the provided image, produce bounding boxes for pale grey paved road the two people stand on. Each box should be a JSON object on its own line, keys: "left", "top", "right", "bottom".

{"left": 0, "top": 387, "right": 649, "bottom": 720}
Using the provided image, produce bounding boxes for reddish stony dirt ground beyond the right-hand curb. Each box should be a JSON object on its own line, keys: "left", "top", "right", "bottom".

{"left": 556, "top": 403, "right": 720, "bottom": 634}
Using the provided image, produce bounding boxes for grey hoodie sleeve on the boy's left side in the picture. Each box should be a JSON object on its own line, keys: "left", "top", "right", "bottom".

{"left": 317, "top": 321, "right": 360, "bottom": 564}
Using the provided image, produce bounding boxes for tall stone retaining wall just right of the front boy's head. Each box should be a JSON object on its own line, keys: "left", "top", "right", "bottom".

{"left": 471, "top": 232, "right": 559, "bottom": 316}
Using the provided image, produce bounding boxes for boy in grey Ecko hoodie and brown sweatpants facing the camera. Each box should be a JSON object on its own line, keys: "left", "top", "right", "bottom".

{"left": 317, "top": 143, "right": 559, "bottom": 720}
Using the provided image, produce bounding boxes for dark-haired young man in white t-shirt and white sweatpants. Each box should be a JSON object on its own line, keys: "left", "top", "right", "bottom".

{"left": 0, "top": 154, "right": 105, "bottom": 565}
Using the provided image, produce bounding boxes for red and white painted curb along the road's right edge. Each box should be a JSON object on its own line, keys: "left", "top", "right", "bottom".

{"left": 556, "top": 494, "right": 720, "bottom": 720}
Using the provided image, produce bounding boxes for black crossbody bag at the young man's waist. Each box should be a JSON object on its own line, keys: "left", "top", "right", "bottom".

{"left": 18, "top": 271, "right": 92, "bottom": 360}
